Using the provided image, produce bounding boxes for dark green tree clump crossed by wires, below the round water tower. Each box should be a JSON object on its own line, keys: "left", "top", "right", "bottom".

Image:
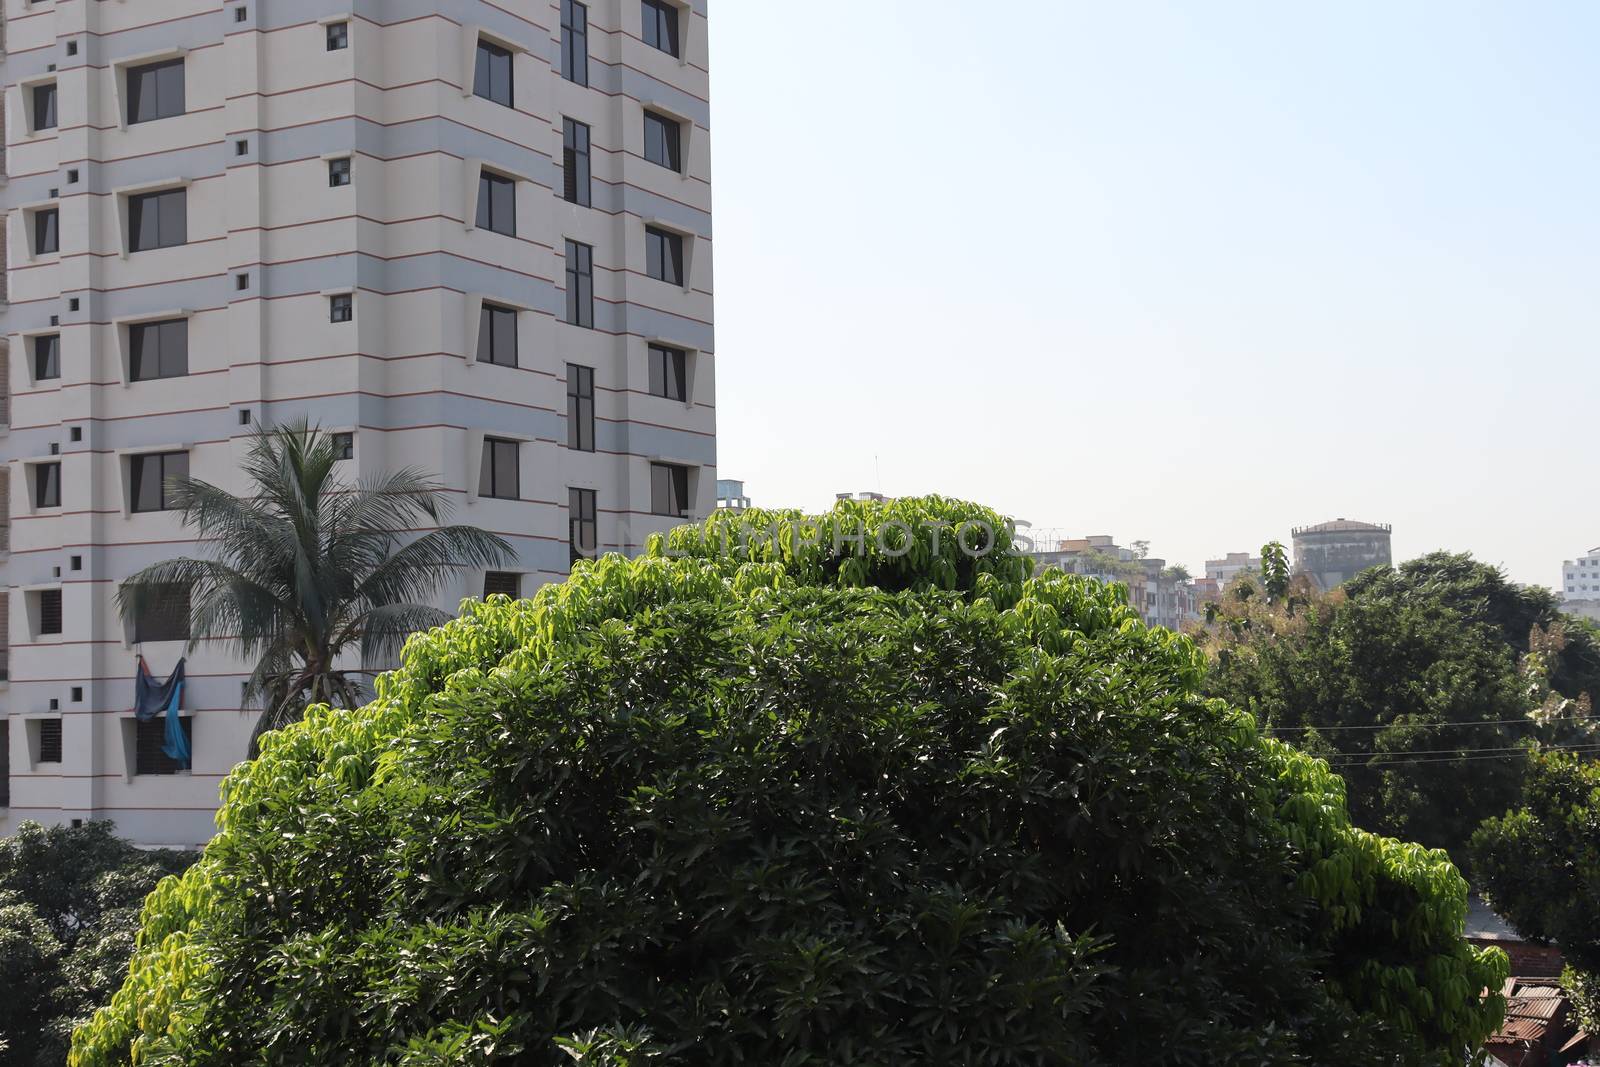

{"left": 1202, "top": 553, "right": 1600, "bottom": 857}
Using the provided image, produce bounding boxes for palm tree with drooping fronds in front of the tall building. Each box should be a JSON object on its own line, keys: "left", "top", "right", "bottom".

{"left": 117, "top": 421, "right": 515, "bottom": 755}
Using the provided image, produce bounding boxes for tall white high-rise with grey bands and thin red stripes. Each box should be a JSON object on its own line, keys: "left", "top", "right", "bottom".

{"left": 0, "top": 0, "right": 717, "bottom": 845}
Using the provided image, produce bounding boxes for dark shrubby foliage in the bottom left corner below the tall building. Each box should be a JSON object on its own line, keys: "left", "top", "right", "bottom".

{"left": 0, "top": 822, "right": 195, "bottom": 1067}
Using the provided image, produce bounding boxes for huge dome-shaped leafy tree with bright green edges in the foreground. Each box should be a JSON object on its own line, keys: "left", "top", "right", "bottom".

{"left": 74, "top": 498, "right": 1506, "bottom": 1067}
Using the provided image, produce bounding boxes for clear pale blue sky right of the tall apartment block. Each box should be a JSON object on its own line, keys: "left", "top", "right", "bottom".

{"left": 710, "top": 0, "right": 1600, "bottom": 585}
